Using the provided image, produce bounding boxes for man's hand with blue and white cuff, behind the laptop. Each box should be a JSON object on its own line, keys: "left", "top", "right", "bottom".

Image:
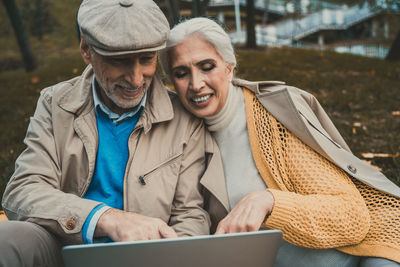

{"left": 94, "top": 208, "right": 177, "bottom": 242}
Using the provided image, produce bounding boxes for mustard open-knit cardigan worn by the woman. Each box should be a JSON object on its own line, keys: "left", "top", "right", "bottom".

{"left": 244, "top": 90, "right": 400, "bottom": 262}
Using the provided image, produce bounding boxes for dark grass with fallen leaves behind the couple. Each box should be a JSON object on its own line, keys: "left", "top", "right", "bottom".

{"left": 0, "top": 48, "right": 400, "bottom": 201}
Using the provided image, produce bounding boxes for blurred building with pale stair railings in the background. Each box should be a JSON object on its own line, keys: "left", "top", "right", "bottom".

{"left": 180, "top": 0, "right": 400, "bottom": 58}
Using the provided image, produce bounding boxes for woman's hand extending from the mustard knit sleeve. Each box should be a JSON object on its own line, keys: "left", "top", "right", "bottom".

{"left": 215, "top": 190, "right": 275, "bottom": 235}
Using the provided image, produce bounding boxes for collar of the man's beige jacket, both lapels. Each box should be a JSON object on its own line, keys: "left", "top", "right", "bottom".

{"left": 58, "top": 65, "right": 174, "bottom": 133}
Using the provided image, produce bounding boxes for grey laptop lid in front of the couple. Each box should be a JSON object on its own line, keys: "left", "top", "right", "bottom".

{"left": 62, "top": 230, "right": 282, "bottom": 267}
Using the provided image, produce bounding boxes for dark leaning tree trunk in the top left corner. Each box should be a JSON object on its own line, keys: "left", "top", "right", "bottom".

{"left": 3, "top": 0, "right": 36, "bottom": 71}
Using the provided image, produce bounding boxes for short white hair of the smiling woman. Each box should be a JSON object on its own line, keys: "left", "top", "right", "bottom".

{"left": 159, "top": 17, "right": 236, "bottom": 76}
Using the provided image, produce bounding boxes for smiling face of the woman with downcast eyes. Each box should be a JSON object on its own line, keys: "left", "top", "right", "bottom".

{"left": 171, "top": 34, "right": 233, "bottom": 118}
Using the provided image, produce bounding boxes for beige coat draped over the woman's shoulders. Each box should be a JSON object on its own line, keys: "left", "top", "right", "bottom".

{"left": 203, "top": 79, "right": 400, "bottom": 231}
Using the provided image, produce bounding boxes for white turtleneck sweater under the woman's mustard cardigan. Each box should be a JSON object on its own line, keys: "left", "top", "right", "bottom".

{"left": 204, "top": 84, "right": 266, "bottom": 209}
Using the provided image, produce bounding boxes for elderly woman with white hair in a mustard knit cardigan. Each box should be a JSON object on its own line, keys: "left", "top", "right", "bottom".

{"left": 160, "top": 18, "right": 400, "bottom": 266}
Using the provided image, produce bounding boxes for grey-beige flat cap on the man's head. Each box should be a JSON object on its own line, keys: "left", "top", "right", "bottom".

{"left": 78, "top": 0, "right": 169, "bottom": 56}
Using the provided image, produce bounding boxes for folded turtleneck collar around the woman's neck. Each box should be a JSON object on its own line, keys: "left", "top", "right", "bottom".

{"left": 204, "top": 83, "right": 242, "bottom": 132}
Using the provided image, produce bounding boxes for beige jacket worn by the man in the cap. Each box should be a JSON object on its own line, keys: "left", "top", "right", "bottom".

{"left": 2, "top": 66, "right": 217, "bottom": 246}
